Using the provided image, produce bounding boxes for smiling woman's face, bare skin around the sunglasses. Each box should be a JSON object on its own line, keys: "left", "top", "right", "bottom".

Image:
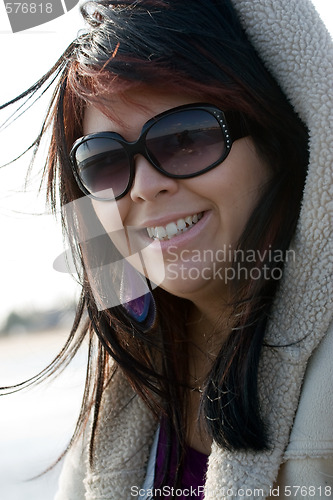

{"left": 84, "top": 90, "right": 270, "bottom": 303}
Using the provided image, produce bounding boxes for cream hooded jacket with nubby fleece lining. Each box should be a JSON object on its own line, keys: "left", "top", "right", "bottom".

{"left": 56, "top": 0, "right": 333, "bottom": 500}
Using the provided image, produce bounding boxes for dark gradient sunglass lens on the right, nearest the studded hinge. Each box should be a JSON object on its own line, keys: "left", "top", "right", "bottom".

{"left": 146, "top": 109, "right": 226, "bottom": 175}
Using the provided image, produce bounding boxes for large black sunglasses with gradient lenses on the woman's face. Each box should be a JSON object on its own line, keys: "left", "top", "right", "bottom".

{"left": 70, "top": 104, "right": 246, "bottom": 201}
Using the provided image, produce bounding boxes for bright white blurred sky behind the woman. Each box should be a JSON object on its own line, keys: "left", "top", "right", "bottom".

{"left": 0, "top": 0, "right": 333, "bottom": 328}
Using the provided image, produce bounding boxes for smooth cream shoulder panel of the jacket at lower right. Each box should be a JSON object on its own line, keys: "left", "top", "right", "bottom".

{"left": 276, "top": 324, "right": 333, "bottom": 498}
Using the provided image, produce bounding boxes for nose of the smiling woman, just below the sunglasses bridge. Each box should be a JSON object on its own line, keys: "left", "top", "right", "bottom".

{"left": 130, "top": 155, "right": 178, "bottom": 203}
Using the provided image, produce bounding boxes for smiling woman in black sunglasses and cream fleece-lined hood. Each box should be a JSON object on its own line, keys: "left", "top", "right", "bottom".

{"left": 1, "top": 0, "right": 333, "bottom": 500}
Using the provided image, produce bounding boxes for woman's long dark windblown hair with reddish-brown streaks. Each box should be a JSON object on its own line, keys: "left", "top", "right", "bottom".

{"left": 0, "top": 0, "right": 308, "bottom": 492}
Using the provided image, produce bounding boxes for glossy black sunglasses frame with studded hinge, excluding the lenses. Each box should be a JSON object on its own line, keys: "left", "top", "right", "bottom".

{"left": 69, "top": 103, "right": 240, "bottom": 201}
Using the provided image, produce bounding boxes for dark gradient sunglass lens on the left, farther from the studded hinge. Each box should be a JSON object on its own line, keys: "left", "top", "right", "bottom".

{"left": 75, "top": 137, "right": 130, "bottom": 198}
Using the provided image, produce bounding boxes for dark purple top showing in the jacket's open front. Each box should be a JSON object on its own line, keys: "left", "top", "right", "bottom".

{"left": 154, "top": 418, "right": 208, "bottom": 500}
